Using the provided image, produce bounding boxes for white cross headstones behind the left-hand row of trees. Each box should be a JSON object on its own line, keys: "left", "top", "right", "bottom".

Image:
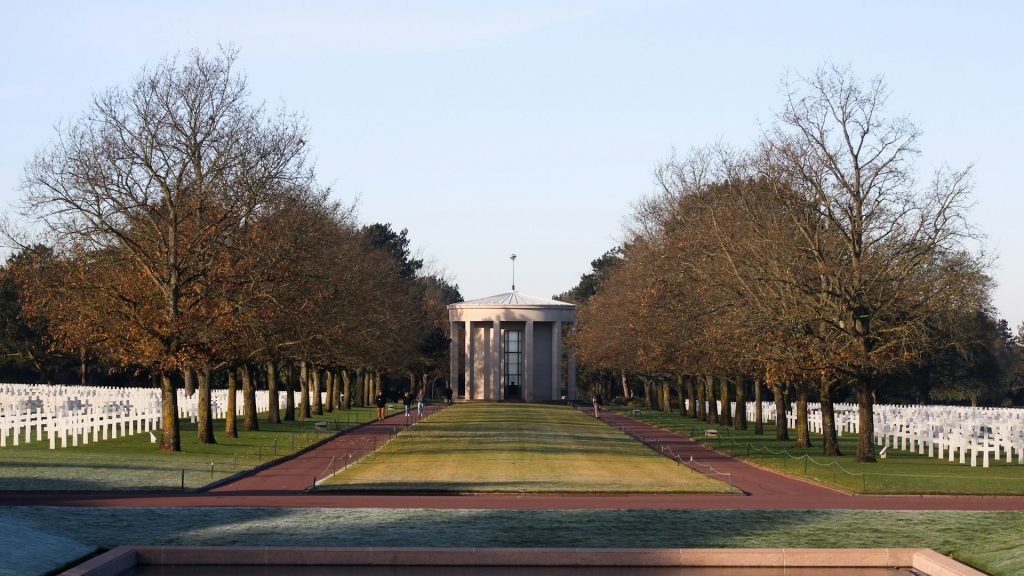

{"left": 0, "top": 383, "right": 323, "bottom": 449}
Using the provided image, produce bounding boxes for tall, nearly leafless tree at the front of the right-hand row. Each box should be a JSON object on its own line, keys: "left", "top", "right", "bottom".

{"left": 755, "top": 67, "right": 980, "bottom": 462}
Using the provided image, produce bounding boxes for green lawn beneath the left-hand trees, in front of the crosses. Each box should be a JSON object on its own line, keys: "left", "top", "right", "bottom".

{"left": 0, "top": 408, "right": 376, "bottom": 491}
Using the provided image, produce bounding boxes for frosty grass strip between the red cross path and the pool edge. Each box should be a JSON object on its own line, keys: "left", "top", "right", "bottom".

{"left": 0, "top": 506, "right": 1024, "bottom": 576}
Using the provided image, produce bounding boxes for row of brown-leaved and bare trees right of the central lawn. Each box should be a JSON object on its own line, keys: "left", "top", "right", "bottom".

{"left": 565, "top": 68, "right": 1010, "bottom": 461}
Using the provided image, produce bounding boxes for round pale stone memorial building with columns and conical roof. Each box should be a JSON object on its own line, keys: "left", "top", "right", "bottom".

{"left": 447, "top": 290, "right": 577, "bottom": 402}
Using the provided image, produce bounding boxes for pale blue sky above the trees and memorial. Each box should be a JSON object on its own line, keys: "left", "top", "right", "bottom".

{"left": 0, "top": 0, "right": 1024, "bottom": 326}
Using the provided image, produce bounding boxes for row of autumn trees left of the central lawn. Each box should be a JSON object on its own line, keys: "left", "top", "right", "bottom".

{"left": 5, "top": 50, "right": 461, "bottom": 451}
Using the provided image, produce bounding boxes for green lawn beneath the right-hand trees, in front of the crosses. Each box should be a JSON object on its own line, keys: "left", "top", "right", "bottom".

{"left": 616, "top": 408, "right": 1024, "bottom": 495}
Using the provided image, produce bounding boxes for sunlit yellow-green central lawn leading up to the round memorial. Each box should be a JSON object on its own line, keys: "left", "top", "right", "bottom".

{"left": 317, "top": 404, "right": 732, "bottom": 493}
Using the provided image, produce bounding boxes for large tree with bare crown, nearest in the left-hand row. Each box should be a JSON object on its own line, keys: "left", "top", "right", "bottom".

{"left": 17, "top": 50, "right": 312, "bottom": 451}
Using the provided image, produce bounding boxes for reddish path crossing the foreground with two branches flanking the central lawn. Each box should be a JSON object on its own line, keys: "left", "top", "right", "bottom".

{"left": 0, "top": 407, "right": 1024, "bottom": 510}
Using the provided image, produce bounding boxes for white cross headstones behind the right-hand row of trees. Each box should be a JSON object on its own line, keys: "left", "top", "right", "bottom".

{"left": 692, "top": 402, "right": 1024, "bottom": 468}
